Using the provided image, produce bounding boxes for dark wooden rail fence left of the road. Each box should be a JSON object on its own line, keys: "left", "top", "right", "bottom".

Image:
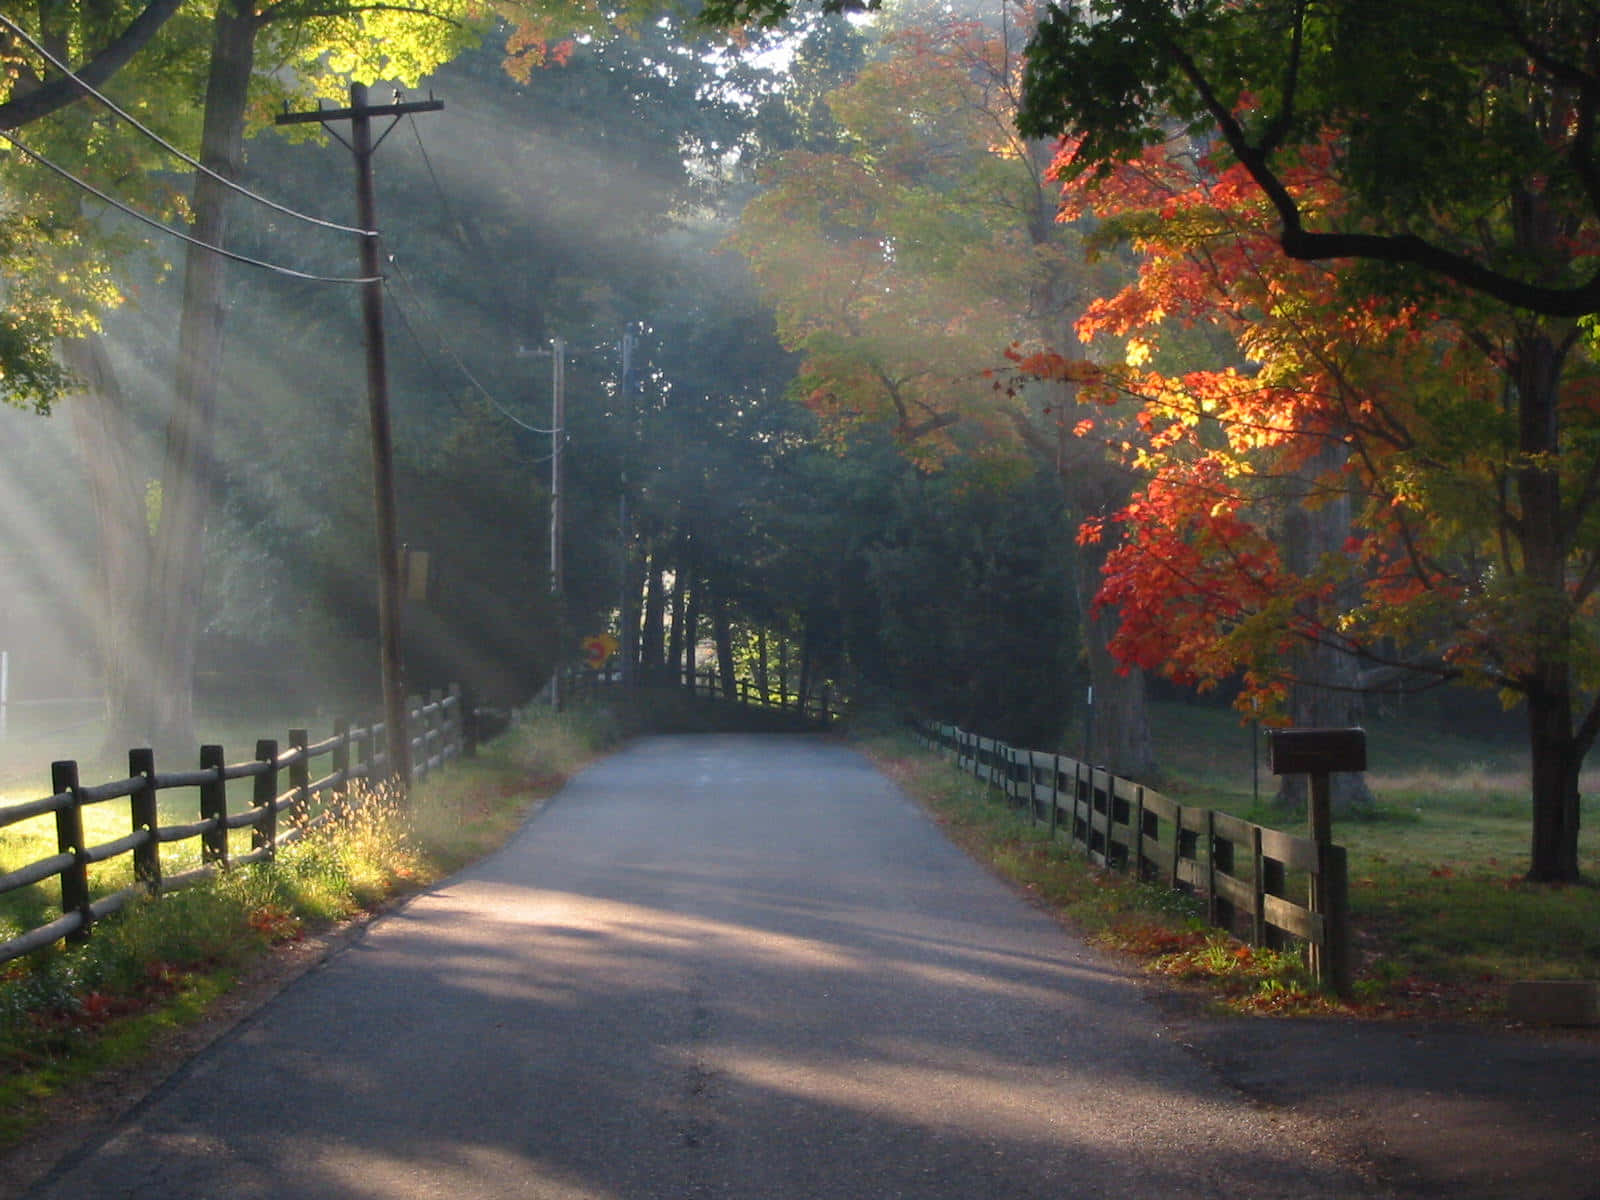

{"left": 0, "top": 688, "right": 464, "bottom": 963}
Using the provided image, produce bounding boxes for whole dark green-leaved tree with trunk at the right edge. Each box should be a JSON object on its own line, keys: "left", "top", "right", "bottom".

{"left": 1019, "top": 0, "right": 1600, "bottom": 880}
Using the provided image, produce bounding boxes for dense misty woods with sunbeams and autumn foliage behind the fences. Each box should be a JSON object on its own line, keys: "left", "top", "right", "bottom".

{"left": 0, "top": 0, "right": 1600, "bottom": 880}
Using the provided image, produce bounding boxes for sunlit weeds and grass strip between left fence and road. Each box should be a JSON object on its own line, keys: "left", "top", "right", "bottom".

{"left": 0, "top": 712, "right": 616, "bottom": 1164}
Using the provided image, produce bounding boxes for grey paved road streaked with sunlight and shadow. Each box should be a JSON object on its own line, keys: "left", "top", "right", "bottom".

{"left": 25, "top": 736, "right": 1374, "bottom": 1200}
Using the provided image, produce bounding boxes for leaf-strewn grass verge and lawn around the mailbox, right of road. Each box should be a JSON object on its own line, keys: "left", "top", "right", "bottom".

{"left": 864, "top": 704, "right": 1600, "bottom": 1019}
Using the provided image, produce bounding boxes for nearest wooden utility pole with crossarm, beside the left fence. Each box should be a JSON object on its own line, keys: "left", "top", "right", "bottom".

{"left": 275, "top": 83, "right": 445, "bottom": 790}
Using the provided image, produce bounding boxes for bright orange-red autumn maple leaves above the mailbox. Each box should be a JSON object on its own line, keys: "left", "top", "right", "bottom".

{"left": 1013, "top": 131, "right": 1595, "bottom": 714}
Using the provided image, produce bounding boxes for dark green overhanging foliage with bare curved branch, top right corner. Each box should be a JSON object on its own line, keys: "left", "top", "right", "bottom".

{"left": 1019, "top": 0, "right": 1600, "bottom": 317}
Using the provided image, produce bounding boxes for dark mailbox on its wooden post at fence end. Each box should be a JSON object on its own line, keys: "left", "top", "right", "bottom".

{"left": 1269, "top": 728, "right": 1366, "bottom": 995}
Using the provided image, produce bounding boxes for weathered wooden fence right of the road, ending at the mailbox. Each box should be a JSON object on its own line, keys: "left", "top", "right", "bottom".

{"left": 915, "top": 722, "right": 1350, "bottom": 994}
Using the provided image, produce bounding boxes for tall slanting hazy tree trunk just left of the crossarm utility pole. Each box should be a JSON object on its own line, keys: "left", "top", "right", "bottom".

{"left": 149, "top": 0, "right": 256, "bottom": 746}
